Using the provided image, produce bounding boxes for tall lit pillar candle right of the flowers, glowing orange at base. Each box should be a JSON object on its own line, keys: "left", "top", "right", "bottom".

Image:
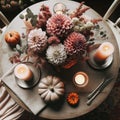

{"left": 94, "top": 42, "right": 114, "bottom": 63}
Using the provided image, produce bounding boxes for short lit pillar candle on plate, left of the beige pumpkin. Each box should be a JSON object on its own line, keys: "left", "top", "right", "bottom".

{"left": 14, "top": 64, "right": 33, "bottom": 81}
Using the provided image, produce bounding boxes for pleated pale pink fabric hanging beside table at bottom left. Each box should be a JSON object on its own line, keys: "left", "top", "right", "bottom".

{"left": 0, "top": 80, "right": 24, "bottom": 120}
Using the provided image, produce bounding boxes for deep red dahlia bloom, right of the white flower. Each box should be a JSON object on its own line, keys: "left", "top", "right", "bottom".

{"left": 64, "top": 32, "right": 86, "bottom": 57}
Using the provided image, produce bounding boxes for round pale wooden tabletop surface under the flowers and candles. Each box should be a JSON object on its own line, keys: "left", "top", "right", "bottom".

{"left": 0, "top": 0, "right": 119, "bottom": 119}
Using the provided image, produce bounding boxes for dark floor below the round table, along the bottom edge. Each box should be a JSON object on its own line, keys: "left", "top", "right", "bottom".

{"left": 19, "top": 70, "right": 120, "bottom": 120}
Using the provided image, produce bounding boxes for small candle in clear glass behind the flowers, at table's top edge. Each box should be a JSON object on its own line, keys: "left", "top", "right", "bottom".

{"left": 54, "top": 3, "right": 66, "bottom": 14}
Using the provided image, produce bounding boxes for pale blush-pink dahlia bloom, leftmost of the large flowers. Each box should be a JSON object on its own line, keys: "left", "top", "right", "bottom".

{"left": 28, "top": 28, "right": 47, "bottom": 53}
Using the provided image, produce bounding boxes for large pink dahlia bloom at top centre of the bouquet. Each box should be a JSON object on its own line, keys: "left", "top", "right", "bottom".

{"left": 46, "top": 14, "right": 73, "bottom": 37}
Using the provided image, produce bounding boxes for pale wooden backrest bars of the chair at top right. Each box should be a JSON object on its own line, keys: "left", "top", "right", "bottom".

{"left": 103, "top": 0, "right": 120, "bottom": 26}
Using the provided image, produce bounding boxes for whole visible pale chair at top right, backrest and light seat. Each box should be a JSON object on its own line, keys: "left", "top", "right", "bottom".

{"left": 103, "top": 0, "right": 120, "bottom": 58}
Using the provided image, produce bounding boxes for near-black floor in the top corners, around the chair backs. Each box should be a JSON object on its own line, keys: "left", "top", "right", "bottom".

{"left": 0, "top": 0, "right": 120, "bottom": 28}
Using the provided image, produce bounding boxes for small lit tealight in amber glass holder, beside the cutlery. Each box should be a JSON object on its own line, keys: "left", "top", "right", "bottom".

{"left": 73, "top": 72, "right": 88, "bottom": 87}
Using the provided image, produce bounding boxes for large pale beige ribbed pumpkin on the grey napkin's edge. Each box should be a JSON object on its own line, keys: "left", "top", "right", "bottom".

{"left": 38, "top": 75, "right": 64, "bottom": 102}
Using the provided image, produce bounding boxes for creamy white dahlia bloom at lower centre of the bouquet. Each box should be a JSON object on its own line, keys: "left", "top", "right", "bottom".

{"left": 46, "top": 44, "right": 67, "bottom": 65}
